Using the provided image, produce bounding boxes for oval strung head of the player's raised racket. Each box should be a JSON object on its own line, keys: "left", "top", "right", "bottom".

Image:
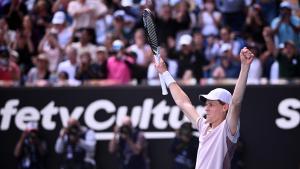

{"left": 143, "top": 8, "right": 158, "bottom": 55}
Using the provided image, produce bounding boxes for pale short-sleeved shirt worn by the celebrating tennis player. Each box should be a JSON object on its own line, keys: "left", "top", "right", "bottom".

{"left": 196, "top": 118, "right": 239, "bottom": 169}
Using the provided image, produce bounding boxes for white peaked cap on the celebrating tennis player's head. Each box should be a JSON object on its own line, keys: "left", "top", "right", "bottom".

{"left": 199, "top": 88, "right": 232, "bottom": 104}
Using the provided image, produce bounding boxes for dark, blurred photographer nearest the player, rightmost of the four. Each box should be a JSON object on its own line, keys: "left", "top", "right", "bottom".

{"left": 171, "top": 123, "right": 198, "bottom": 169}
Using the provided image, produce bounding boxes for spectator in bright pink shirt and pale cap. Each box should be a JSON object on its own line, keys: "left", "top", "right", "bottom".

{"left": 107, "top": 40, "right": 134, "bottom": 84}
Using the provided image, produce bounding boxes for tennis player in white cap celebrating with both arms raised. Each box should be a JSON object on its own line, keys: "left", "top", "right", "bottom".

{"left": 156, "top": 47, "right": 254, "bottom": 169}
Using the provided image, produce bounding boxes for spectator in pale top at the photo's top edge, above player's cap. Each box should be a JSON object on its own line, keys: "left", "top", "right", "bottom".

{"left": 199, "top": 0, "right": 222, "bottom": 36}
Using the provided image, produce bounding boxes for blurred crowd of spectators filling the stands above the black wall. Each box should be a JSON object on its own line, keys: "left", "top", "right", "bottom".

{"left": 0, "top": 0, "right": 300, "bottom": 86}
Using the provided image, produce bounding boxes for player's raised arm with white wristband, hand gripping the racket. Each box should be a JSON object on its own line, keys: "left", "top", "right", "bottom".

{"left": 155, "top": 59, "right": 200, "bottom": 125}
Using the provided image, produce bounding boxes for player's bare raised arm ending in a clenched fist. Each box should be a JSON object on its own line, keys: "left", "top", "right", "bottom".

{"left": 226, "top": 47, "right": 254, "bottom": 135}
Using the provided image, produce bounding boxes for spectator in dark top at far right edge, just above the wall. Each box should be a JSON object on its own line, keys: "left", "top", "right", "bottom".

{"left": 273, "top": 41, "right": 300, "bottom": 79}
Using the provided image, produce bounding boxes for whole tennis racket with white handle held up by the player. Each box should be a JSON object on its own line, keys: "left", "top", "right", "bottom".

{"left": 143, "top": 8, "right": 168, "bottom": 95}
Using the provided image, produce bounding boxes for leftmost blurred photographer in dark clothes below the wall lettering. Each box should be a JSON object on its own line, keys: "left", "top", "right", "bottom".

{"left": 14, "top": 122, "right": 46, "bottom": 169}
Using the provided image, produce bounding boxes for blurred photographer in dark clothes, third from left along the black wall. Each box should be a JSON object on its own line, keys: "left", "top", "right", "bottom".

{"left": 109, "top": 116, "right": 149, "bottom": 169}
